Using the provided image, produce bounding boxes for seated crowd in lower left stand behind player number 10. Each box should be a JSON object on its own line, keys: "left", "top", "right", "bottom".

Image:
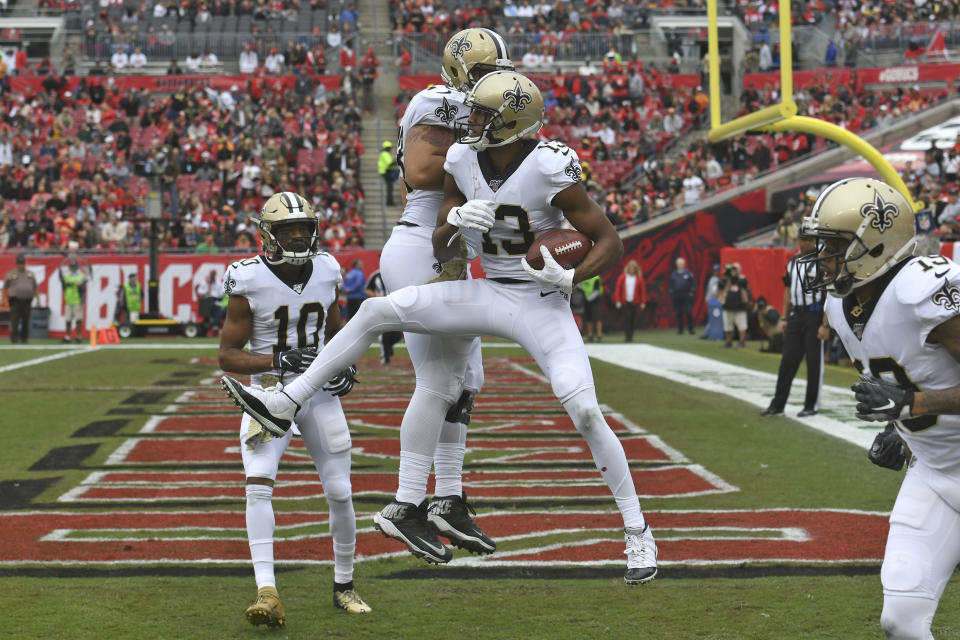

{"left": 0, "top": 74, "right": 364, "bottom": 252}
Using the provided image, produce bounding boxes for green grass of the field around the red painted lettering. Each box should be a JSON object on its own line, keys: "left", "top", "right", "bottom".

{"left": 0, "top": 332, "right": 960, "bottom": 640}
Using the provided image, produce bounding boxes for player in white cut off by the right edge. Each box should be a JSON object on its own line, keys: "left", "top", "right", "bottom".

{"left": 801, "top": 178, "right": 960, "bottom": 640}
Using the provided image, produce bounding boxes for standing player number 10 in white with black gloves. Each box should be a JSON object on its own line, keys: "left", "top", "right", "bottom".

{"left": 219, "top": 192, "right": 370, "bottom": 627}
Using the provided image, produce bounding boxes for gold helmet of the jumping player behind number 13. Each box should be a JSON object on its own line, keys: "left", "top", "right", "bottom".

{"left": 440, "top": 28, "right": 513, "bottom": 92}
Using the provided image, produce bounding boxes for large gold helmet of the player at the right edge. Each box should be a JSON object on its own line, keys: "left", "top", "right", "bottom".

{"left": 800, "top": 178, "right": 916, "bottom": 298}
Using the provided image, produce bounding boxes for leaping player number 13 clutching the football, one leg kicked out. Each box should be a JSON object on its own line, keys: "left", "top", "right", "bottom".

{"left": 222, "top": 71, "right": 657, "bottom": 584}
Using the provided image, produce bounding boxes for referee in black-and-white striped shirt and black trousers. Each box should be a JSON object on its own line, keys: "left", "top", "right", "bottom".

{"left": 762, "top": 236, "right": 830, "bottom": 418}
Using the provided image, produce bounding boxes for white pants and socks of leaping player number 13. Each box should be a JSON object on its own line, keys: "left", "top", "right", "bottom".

{"left": 284, "top": 280, "right": 643, "bottom": 527}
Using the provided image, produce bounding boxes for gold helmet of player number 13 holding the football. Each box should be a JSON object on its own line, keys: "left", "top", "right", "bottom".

{"left": 457, "top": 71, "right": 543, "bottom": 151}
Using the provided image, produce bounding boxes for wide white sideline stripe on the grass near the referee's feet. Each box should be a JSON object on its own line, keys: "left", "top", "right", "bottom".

{"left": 587, "top": 344, "right": 882, "bottom": 448}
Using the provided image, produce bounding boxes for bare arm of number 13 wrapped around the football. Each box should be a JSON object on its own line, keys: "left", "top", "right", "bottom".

{"left": 552, "top": 183, "right": 623, "bottom": 283}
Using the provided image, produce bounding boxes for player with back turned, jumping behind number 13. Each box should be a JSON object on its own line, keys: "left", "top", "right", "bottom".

{"left": 380, "top": 28, "right": 513, "bottom": 560}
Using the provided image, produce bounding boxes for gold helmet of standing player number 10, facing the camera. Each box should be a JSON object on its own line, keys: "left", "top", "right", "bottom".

{"left": 257, "top": 191, "right": 320, "bottom": 265}
